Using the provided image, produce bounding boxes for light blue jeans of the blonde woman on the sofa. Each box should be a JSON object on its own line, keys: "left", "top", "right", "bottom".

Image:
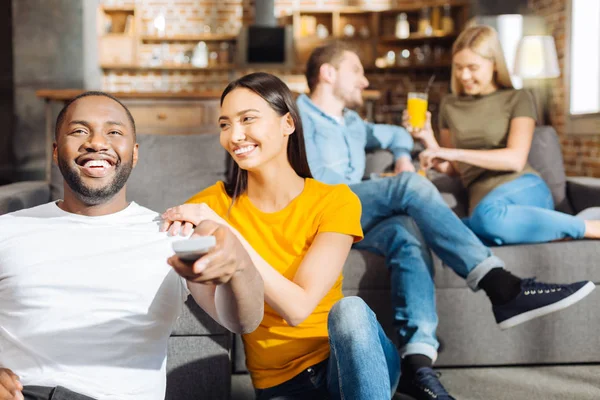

{"left": 463, "top": 174, "right": 585, "bottom": 245}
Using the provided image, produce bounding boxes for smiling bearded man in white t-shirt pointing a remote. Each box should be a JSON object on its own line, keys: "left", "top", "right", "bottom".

{"left": 0, "top": 92, "right": 264, "bottom": 400}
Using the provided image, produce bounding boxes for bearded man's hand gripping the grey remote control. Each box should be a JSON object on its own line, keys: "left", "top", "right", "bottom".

{"left": 167, "top": 220, "right": 252, "bottom": 285}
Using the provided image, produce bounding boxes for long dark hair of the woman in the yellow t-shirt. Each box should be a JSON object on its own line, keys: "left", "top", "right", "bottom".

{"left": 221, "top": 72, "right": 312, "bottom": 205}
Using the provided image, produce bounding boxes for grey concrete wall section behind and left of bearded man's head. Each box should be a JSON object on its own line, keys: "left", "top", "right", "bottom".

{"left": 12, "top": 0, "right": 84, "bottom": 180}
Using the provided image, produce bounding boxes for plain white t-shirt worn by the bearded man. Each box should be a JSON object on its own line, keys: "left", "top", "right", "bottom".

{"left": 0, "top": 203, "right": 189, "bottom": 400}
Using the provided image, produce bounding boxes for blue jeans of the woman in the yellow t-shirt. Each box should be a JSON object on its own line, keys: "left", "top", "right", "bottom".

{"left": 256, "top": 296, "right": 400, "bottom": 400}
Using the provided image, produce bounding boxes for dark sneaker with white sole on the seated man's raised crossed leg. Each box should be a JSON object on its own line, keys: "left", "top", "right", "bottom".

{"left": 492, "top": 278, "right": 596, "bottom": 329}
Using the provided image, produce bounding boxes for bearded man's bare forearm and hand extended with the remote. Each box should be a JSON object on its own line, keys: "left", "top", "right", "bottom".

{"left": 169, "top": 221, "right": 264, "bottom": 334}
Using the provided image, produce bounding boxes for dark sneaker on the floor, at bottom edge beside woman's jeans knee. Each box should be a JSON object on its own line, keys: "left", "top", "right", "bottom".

{"left": 396, "top": 367, "right": 456, "bottom": 400}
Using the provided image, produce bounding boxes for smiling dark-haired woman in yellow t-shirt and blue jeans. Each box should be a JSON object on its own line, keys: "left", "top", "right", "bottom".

{"left": 163, "top": 73, "right": 400, "bottom": 400}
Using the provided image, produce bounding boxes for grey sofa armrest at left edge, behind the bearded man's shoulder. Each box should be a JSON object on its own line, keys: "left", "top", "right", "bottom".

{"left": 0, "top": 181, "right": 50, "bottom": 215}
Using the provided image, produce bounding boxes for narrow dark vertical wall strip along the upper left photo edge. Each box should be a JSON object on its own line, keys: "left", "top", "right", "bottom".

{"left": 0, "top": 1, "right": 15, "bottom": 185}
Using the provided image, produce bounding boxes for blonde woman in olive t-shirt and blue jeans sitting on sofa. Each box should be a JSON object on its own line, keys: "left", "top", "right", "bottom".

{"left": 405, "top": 26, "right": 600, "bottom": 245}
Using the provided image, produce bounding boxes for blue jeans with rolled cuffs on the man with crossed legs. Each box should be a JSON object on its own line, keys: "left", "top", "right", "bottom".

{"left": 350, "top": 172, "right": 504, "bottom": 361}
